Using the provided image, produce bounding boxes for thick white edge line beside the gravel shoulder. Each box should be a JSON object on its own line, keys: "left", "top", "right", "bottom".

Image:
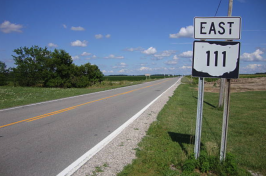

{"left": 57, "top": 78, "right": 181, "bottom": 176}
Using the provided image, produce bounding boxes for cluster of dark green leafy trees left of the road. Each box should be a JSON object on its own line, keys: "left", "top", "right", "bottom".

{"left": 0, "top": 46, "right": 104, "bottom": 88}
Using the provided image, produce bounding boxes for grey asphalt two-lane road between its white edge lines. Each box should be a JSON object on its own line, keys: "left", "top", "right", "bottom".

{"left": 0, "top": 78, "right": 178, "bottom": 176}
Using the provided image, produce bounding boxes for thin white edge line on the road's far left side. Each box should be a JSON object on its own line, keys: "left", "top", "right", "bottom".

{"left": 0, "top": 80, "right": 164, "bottom": 112}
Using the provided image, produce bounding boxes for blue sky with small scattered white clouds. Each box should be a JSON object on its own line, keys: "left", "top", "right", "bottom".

{"left": 0, "top": 0, "right": 266, "bottom": 75}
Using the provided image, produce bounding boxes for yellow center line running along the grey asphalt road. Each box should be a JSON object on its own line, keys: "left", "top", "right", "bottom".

{"left": 0, "top": 80, "right": 168, "bottom": 128}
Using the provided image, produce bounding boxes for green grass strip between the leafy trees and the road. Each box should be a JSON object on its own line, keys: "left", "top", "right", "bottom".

{"left": 0, "top": 81, "right": 148, "bottom": 109}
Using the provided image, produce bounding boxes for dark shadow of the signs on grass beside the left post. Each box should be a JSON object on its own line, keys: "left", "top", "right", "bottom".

{"left": 168, "top": 132, "right": 203, "bottom": 156}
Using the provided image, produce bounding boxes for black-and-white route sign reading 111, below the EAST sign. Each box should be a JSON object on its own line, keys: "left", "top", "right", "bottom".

{"left": 192, "top": 41, "right": 240, "bottom": 78}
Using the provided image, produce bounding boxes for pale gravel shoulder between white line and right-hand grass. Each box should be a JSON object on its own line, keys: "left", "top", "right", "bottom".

{"left": 73, "top": 79, "right": 181, "bottom": 176}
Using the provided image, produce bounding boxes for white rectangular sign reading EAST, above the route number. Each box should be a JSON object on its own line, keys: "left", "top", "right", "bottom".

{"left": 194, "top": 17, "right": 241, "bottom": 40}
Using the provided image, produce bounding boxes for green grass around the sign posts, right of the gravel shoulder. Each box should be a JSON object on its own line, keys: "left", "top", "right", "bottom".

{"left": 118, "top": 77, "right": 266, "bottom": 176}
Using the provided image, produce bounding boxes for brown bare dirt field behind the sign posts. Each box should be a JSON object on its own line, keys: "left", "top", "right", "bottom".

{"left": 204, "top": 77, "right": 266, "bottom": 93}
